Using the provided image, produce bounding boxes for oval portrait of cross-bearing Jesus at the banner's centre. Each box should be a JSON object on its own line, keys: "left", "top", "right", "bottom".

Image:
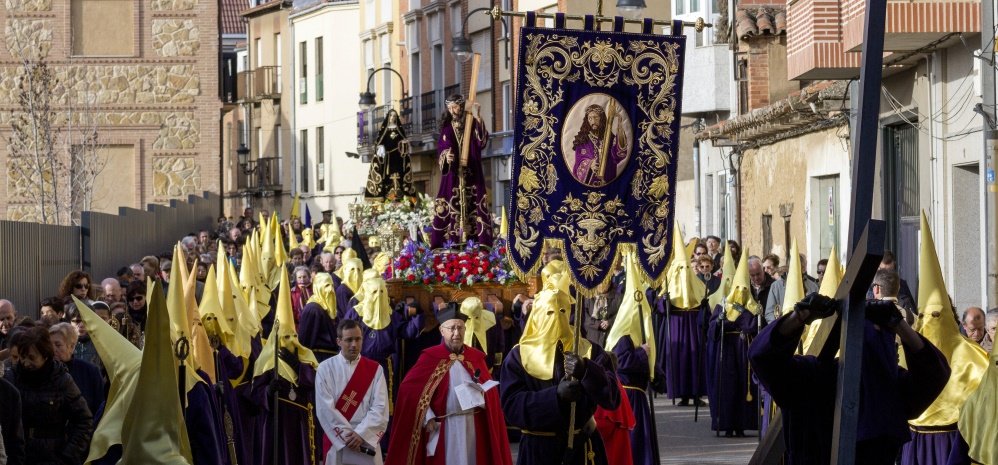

{"left": 561, "top": 93, "right": 634, "bottom": 187}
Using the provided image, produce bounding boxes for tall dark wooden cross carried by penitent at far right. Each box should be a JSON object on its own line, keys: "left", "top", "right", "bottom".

{"left": 749, "top": 0, "right": 887, "bottom": 465}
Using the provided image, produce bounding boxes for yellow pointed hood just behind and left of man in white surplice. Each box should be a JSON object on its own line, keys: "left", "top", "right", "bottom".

{"left": 253, "top": 273, "right": 319, "bottom": 386}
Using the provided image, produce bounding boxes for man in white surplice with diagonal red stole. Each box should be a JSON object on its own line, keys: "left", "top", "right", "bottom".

{"left": 315, "top": 320, "right": 388, "bottom": 465}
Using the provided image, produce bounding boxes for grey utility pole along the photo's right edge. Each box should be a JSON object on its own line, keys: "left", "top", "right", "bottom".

{"left": 980, "top": 0, "right": 998, "bottom": 308}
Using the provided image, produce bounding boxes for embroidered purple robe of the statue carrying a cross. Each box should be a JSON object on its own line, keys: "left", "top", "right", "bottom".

{"left": 430, "top": 114, "right": 492, "bottom": 249}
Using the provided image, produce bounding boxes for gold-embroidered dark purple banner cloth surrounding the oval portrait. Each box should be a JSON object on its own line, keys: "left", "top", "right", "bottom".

{"left": 509, "top": 33, "right": 679, "bottom": 295}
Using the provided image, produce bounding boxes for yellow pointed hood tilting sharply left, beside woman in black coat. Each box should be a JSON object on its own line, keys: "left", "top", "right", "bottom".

{"left": 73, "top": 297, "right": 142, "bottom": 464}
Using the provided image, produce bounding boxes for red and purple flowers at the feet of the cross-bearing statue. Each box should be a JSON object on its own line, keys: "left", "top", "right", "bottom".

{"left": 388, "top": 239, "right": 517, "bottom": 287}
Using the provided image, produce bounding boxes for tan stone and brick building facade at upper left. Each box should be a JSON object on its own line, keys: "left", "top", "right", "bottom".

{"left": 0, "top": 0, "right": 221, "bottom": 221}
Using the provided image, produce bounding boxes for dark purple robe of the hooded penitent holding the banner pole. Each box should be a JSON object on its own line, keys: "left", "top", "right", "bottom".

{"left": 499, "top": 346, "right": 620, "bottom": 465}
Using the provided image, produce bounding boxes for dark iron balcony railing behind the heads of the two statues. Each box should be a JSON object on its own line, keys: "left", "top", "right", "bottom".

{"left": 357, "top": 84, "right": 461, "bottom": 157}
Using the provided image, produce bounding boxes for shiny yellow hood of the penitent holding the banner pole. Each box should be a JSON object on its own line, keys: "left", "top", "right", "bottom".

{"left": 520, "top": 274, "right": 592, "bottom": 380}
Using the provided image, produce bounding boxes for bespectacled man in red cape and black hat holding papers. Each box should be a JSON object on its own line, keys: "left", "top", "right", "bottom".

{"left": 385, "top": 308, "right": 512, "bottom": 465}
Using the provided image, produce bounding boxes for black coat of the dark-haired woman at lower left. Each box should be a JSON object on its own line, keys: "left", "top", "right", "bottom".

{"left": 6, "top": 360, "right": 93, "bottom": 465}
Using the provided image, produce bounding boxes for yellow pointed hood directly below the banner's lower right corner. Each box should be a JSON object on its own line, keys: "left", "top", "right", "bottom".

{"left": 605, "top": 249, "right": 658, "bottom": 377}
